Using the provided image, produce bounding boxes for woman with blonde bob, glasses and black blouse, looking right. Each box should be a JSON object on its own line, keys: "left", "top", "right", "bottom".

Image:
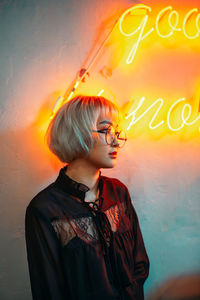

{"left": 26, "top": 96, "right": 149, "bottom": 300}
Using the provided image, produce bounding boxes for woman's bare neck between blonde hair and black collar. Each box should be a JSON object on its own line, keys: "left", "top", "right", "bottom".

{"left": 66, "top": 159, "right": 100, "bottom": 193}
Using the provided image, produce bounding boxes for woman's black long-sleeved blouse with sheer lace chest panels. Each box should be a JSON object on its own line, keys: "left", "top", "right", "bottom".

{"left": 25, "top": 166, "right": 149, "bottom": 300}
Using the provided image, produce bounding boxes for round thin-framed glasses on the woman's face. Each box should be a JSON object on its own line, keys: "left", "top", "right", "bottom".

{"left": 93, "top": 126, "right": 127, "bottom": 148}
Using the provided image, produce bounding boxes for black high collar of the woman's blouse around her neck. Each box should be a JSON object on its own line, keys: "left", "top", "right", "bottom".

{"left": 54, "top": 165, "right": 103, "bottom": 202}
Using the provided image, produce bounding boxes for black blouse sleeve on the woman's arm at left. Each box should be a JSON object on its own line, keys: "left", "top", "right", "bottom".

{"left": 25, "top": 206, "right": 70, "bottom": 300}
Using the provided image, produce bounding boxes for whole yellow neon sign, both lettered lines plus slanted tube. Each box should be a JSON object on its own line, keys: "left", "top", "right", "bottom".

{"left": 51, "top": 4, "right": 200, "bottom": 132}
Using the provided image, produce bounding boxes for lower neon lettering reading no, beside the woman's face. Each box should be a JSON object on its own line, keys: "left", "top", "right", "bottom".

{"left": 125, "top": 97, "right": 200, "bottom": 131}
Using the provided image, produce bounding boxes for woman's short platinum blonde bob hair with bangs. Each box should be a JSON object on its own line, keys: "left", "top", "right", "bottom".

{"left": 45, "top": 95, "right": 121, "bottom": 163}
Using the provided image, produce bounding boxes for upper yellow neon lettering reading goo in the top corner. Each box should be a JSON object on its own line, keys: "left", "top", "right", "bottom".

{"left": 119, "top": 4, "right": 200, "bottom": 64}
